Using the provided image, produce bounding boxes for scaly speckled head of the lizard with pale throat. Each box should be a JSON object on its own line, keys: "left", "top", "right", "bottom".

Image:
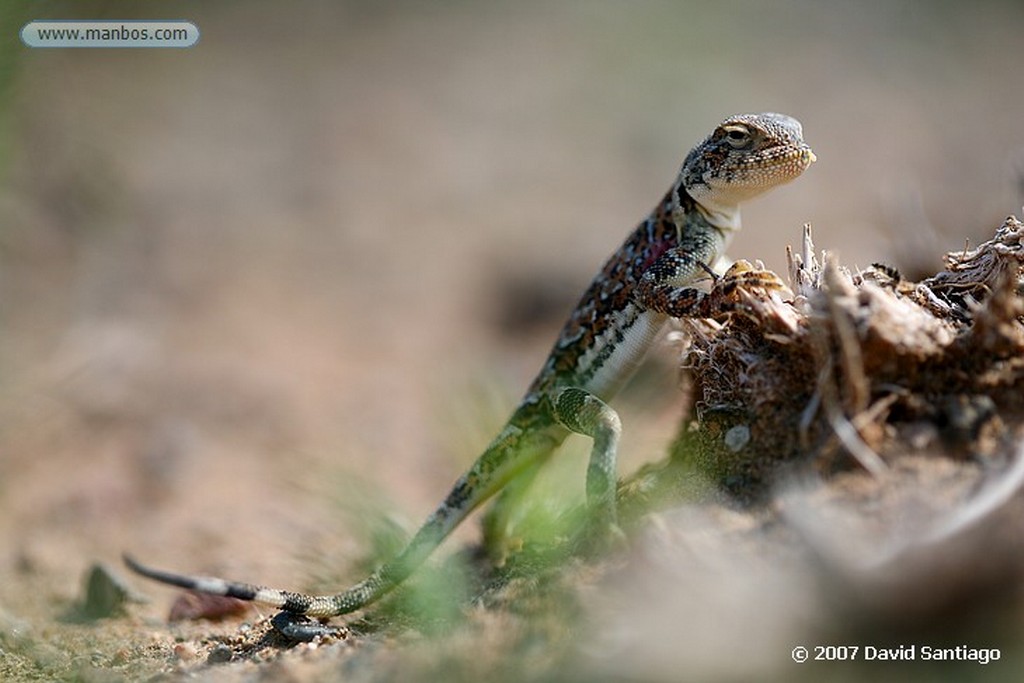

{"left": 676, "top": 114, "right": 815, "bottom": 228}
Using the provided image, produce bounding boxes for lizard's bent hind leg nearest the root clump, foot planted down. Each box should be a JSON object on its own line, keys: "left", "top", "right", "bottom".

{"left": 555, "top": 387, "right": 623, "bottom": 532}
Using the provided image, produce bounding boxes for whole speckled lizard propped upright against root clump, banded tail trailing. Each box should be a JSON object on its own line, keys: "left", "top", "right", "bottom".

{"left": 124, "top": 113, "right": 815, "bottom": 617}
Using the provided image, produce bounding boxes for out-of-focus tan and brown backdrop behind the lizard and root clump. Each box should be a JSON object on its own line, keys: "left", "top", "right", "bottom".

{"left": 0, "top": 0, "right": 1024, "bottom": 671}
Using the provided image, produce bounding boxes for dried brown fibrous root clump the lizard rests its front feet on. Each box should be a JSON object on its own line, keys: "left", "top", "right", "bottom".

{"left": 659, "top": 216, "right": 1024, "bottom": 499}
